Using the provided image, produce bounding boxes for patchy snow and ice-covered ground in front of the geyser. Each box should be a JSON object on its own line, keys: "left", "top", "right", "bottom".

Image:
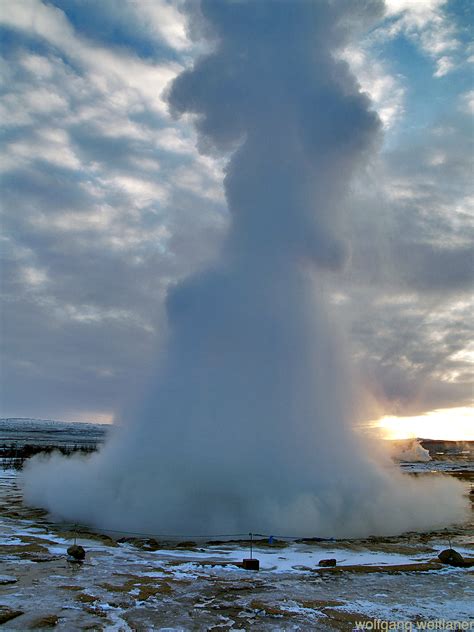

{"left": 0, "top": 470, "right": 474, "bottom": 631}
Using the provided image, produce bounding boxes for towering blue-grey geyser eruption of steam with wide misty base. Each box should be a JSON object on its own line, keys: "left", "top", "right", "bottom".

{"left": 25, "top": 0, "right": 464, "bottom": 536}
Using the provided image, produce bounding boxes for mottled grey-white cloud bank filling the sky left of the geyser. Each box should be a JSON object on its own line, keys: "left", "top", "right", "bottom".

{"left": 1, "top": 3, "right": 224, "bottom": 418}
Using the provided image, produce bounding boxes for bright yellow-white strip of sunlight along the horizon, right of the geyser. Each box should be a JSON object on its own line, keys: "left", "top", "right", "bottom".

{"left": 374, "top": 406, "right": 474, "bottom": 441}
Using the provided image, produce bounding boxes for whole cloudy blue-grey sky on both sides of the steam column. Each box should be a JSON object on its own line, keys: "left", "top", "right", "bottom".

{"left": 0, "top": 0, "right": 474, "bottom": 436}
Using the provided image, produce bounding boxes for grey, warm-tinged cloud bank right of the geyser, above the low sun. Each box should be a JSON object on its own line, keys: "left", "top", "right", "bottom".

{"left": 339, "top": 102, "right": 474, "bottom": 414}
